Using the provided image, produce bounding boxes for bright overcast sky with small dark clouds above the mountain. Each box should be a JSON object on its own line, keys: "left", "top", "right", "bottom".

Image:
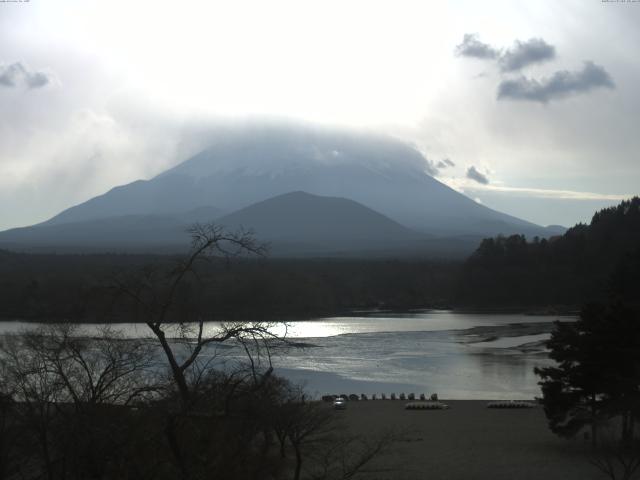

{"left": 0, "top": 0, "right": 640, "bottom": 229}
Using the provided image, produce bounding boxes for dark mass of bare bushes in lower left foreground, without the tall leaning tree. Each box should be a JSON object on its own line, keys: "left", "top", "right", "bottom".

{"left": 0, "top": 326, "right": 394, "bottom": 480}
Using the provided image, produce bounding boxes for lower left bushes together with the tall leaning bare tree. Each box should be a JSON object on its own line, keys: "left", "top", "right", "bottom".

{"left": 0, "top": 226, "right": 394, "bottom": 480}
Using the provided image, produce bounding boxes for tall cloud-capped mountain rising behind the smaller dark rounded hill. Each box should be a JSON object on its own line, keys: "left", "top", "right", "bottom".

{"left": 40, "top": 125, "right": 548, "bottom": 236}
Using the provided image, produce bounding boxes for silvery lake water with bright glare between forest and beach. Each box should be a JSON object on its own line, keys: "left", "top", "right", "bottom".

{"left": 0, "top": 311, "right": 575, "bottom": 399}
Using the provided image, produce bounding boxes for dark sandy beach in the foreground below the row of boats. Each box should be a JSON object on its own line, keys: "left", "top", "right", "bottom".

{"left": 338, "top": 400, "right": 604, "bottom": 480}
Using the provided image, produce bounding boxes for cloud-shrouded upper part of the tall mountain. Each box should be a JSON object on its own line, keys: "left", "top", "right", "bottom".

{"left": 159, "top": 123, "right": 430, "bottom": 182}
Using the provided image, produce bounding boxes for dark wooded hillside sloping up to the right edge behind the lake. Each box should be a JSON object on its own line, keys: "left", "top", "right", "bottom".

{"left": 455, "top": 197, "right": 640, "bottom": 308}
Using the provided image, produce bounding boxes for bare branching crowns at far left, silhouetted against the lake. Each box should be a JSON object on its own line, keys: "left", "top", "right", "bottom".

{"left": 2, "top": 324, "right": 158, "bottom": 410}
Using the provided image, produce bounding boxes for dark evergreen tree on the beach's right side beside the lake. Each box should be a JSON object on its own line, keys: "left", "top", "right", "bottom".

{"left": 535, "top": 303, "right": 640, "bottom": 443}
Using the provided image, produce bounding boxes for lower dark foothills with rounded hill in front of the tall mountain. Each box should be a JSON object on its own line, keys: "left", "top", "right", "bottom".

{"left": 0, "top": 192, "right": 436, "bottom": 256}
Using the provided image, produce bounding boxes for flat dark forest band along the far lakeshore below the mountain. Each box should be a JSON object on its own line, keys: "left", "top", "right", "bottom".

{"left": 0, "top": 251, "right": 461, "bottom": 322}
